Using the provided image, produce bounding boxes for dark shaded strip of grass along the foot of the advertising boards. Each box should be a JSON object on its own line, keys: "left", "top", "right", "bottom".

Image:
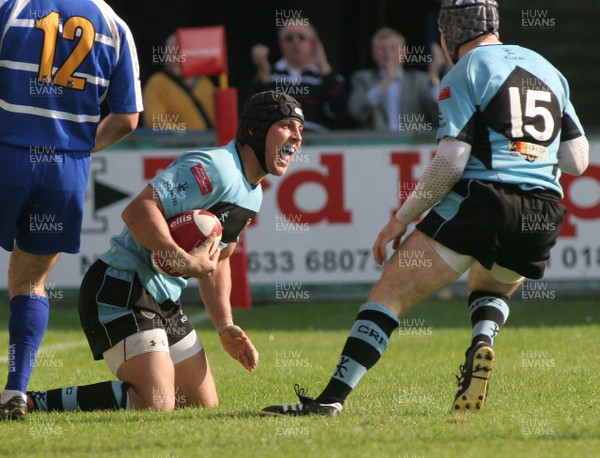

{"left": 0, "top": 299, "right": 600, "bottom": 332}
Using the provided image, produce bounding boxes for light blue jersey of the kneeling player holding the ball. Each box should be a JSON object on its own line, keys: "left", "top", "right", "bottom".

{"left": 100, "top": 141, "right": 262, "bottom": 304}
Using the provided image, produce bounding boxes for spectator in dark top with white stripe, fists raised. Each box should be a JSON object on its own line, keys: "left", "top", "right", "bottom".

{"left": 251, "top": 18, "right": 347, "bottom": 132}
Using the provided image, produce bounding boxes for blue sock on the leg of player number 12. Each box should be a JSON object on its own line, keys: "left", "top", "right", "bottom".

{"left": 5, "top": 294, "right": 50, "bottom": 393}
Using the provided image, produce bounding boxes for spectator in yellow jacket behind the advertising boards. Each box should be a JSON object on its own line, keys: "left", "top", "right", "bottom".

{"left": 142, "top": 34, "right": 215, "bottom": 132}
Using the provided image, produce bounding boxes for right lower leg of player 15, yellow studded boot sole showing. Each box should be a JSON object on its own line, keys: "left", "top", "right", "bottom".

{"left": 452, "top": 262, "right": 523, "bottom": 411}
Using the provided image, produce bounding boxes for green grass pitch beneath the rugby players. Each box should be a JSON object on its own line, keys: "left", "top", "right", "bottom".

{"left": 0, "top": 300, "right": 600, "bottom": 458}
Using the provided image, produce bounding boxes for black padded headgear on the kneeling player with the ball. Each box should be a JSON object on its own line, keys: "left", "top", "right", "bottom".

{"left": 236, "top": 91, "right": 304, "bottom": 172}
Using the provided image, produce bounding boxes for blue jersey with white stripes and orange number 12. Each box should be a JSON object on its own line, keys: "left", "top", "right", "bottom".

{"left": 0, "top": 0, "right": 143, "bottom": 152}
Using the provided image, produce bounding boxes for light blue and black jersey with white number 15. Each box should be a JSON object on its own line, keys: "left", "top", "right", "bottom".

{"left": 437, "top": 44, "right": 583, "bottom": 196}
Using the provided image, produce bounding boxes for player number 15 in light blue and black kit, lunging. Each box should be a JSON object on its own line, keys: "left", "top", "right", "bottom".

{"left": 263, "top": 0, "right": 589, "bottom": 416}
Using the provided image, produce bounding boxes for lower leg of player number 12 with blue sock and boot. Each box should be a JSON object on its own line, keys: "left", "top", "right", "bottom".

{"left": 0, "top": 246, "right": 59, "bottom": 420}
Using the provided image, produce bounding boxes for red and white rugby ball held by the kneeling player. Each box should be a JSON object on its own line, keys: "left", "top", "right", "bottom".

{"left": 152, "top": 210, "right": 223, "bottom": 277}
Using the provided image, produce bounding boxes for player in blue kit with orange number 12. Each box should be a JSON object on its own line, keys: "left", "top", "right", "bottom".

{"left": 0, "top": 0, "right": 142, "bottom": 420}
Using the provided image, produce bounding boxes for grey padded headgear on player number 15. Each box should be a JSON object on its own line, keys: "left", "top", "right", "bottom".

{"left": 438, "top": 0, "right": 500, "bottom": 63}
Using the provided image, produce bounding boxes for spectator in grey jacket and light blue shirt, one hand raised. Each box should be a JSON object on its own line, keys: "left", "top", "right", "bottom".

{"left": 348, "top": 27, "right": 446, "bottom": 132}
